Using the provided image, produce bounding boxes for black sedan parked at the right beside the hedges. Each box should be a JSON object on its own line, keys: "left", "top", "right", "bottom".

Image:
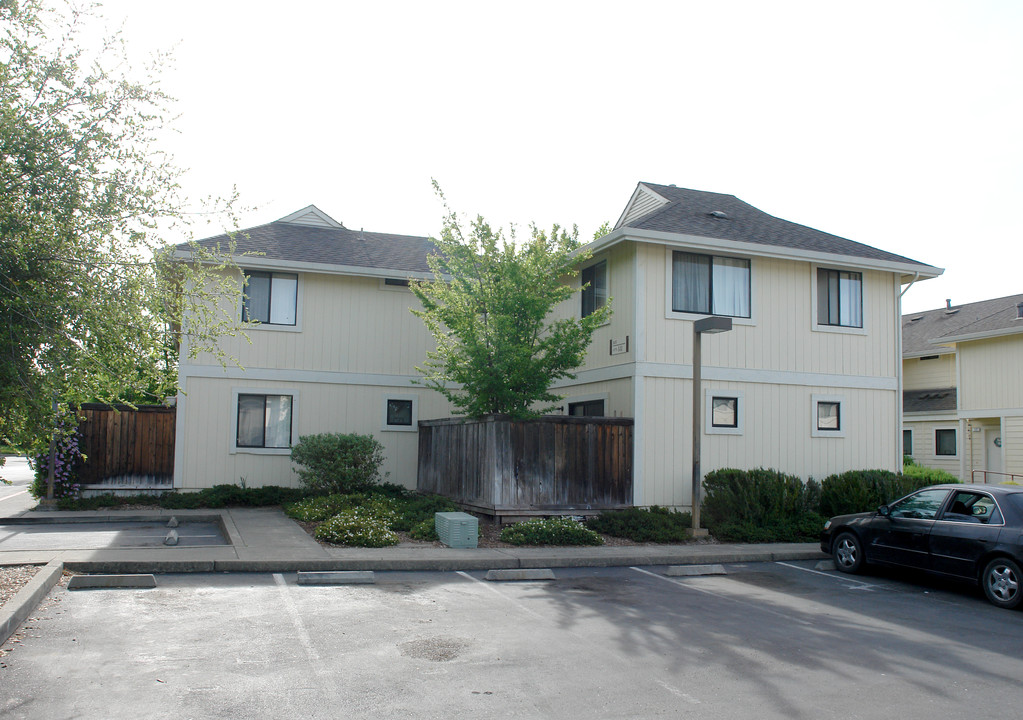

{"left": 820, "top": 485, "right": 1023, "bottom": 608}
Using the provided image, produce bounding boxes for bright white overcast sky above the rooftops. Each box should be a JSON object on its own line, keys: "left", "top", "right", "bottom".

{"left": 90, "top": 0, "right": 1023, "bottom": 312}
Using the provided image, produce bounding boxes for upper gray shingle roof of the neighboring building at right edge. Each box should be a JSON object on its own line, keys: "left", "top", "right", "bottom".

{"left": 902, "top": 295, "right": 1023, "bottom": 355}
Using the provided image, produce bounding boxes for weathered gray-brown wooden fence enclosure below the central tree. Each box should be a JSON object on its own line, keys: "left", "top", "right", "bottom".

{"left": 417, "top": 415, "right": 633, "bottom": 518}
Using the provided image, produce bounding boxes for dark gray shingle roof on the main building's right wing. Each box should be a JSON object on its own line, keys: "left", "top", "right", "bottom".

{"left": 625, "top": 182, "right": 929, "bottom": 267}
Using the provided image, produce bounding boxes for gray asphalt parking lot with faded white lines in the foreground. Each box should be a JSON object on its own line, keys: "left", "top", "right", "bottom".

{"left": 0, "top": 563, "right": 1023, "bottom": 719}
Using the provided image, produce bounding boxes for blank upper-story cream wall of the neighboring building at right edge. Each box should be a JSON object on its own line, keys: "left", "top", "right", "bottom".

{"left": 959, "top": 335, "right": 1023, "bottom": 411}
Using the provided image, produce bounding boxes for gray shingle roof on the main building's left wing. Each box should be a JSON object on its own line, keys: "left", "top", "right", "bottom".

{"left": 178, "top": 220, "right": 435, "bottom": 272}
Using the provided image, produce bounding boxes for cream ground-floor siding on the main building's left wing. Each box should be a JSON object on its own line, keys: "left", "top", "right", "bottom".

{"left": 175, "top": 377, "right": 450, "bottom": 489}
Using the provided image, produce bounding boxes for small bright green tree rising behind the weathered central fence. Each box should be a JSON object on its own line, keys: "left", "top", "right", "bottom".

{"left": 411, "top": 182, "right": 611, "bottom": 418}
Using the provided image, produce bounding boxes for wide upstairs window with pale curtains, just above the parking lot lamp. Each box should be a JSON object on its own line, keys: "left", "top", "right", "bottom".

{"left": 671, "top": 251, "right": 750, "bottom": 317}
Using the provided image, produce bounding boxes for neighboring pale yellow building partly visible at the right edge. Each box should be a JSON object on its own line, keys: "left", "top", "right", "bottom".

{"left": 902, "top": 295, "right": 1023, "bottom": 483}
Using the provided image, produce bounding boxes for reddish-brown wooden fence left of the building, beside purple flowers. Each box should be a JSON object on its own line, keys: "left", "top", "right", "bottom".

{"left": 78, "top": 404, "right": 175, "bottom": 485}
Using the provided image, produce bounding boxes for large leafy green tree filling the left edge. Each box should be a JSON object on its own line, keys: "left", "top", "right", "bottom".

{"left": 0, "top": 0, "right": 239, "bottom": 478}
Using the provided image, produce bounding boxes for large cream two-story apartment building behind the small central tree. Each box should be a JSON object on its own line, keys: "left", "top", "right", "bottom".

{"left": 175, "top": 183, "right": 941, "bottom": 506}
